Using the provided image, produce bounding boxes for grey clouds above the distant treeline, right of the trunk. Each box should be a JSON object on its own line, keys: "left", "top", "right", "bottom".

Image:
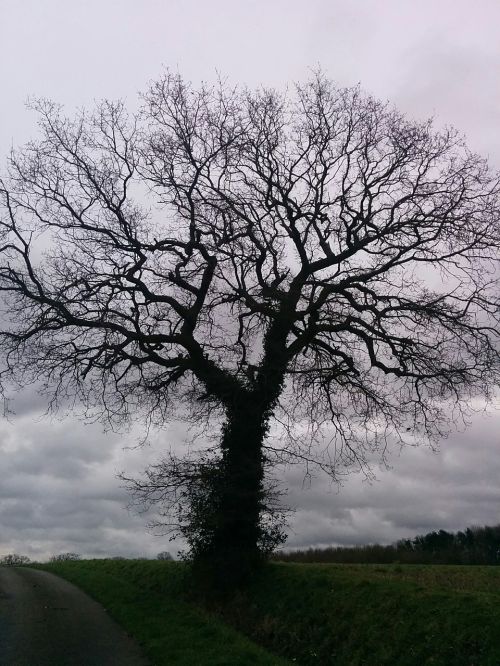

{"left": 287, "top": 415, "right": 500, "bottom": 548}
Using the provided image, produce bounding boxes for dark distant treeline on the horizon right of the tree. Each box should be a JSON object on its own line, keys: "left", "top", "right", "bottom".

{"left": 273, "top": 525, "right": 500, "bottom": 564}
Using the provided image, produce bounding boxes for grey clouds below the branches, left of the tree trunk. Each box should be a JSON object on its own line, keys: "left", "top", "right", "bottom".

{"left": 0, "top": 416, "right": 173, "bottom": 557}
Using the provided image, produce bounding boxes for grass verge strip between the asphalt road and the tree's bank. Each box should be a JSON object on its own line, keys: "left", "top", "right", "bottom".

{"left": 40, "top": 560, "right": 288, "bottom": 666}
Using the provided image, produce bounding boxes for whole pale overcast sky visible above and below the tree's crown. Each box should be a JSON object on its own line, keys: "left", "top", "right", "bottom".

{"left": 0, "top": 0, "right": 500, "bottom": 558}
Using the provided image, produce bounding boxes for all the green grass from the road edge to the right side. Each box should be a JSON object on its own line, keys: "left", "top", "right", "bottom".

{"left": 39, "top": 560, "right": 500, "bottom": 666}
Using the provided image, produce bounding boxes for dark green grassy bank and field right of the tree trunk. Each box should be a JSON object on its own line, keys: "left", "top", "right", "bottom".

{"left": 225, "top": 564, "right": 500, "bottom": 666}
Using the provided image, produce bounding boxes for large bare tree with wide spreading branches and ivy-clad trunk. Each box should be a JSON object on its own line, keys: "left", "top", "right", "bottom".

{"left": 0, "top": 74, "right": 500, "bottom": 572}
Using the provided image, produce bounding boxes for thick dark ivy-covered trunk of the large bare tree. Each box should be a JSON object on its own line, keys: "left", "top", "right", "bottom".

{"left": 195, "top": 304, "right": 297, "bottom": 590}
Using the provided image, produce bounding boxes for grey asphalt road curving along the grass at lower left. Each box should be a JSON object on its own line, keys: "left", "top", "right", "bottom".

{"left": 0, "top": 567, "right": 148, "bottom": 666}
